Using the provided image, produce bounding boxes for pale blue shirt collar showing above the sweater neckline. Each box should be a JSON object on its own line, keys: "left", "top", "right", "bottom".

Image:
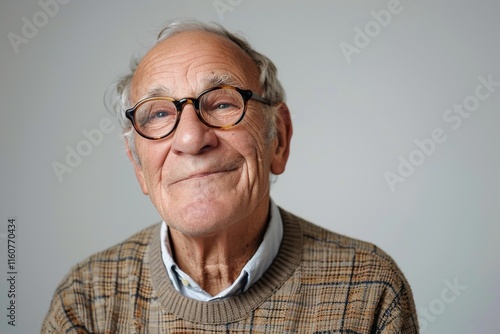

{"left": 160, "top": 200, "right": 283, "bottom": 301}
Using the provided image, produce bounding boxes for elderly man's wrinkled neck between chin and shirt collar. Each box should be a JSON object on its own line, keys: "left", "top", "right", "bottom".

{"left": 169, "top": 198, "right": 269, "bottom": 296}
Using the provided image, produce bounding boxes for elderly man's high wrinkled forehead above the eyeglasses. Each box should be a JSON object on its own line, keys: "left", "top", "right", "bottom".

{"left": 130, "top": 31, "right": 260, "bottom": 103}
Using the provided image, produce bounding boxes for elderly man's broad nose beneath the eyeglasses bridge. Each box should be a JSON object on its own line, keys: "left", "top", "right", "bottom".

{"left": 171, "top": 100, "right": 218, "bottom": 155}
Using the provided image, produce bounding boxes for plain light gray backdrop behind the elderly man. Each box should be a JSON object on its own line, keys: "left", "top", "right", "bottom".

{"left": 0, "top": 0, "right": 500, "bottom": 334}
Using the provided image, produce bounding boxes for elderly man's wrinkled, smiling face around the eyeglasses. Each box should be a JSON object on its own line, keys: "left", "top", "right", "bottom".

{"left": 131, "top": 31, "right": 289, "bottom": 236}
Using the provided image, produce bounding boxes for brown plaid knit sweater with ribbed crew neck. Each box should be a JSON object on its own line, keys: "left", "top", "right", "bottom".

{"left": 42, "top": 210, "right": 418, "bottom": 334}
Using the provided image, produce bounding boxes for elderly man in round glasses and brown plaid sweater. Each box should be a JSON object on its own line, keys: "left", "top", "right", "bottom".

{"left": 42, "top": 21, "right": 418, "bottom": 333}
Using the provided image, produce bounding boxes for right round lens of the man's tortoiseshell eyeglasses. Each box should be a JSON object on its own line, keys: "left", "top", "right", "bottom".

{"left": 200, "top": 88, "right": 245, "bottom": 127}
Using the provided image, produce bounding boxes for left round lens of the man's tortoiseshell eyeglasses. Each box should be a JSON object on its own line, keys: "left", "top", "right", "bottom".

{"left": 135, "top": 100, "right": 177, "bottom": 137}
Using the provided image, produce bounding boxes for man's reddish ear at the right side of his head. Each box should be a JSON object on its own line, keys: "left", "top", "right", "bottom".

{"left": 271, "top": 103, "right": 293, "bottom": 175}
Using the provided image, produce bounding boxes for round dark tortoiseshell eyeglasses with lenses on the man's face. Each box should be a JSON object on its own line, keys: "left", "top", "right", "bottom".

{"left": 125, "top": 86, "right": 270, "bottom": 140}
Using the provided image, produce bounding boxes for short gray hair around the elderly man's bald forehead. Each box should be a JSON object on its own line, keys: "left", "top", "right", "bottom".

{"left": 105, "top": 19, "right": 285, "bottom": 164}
